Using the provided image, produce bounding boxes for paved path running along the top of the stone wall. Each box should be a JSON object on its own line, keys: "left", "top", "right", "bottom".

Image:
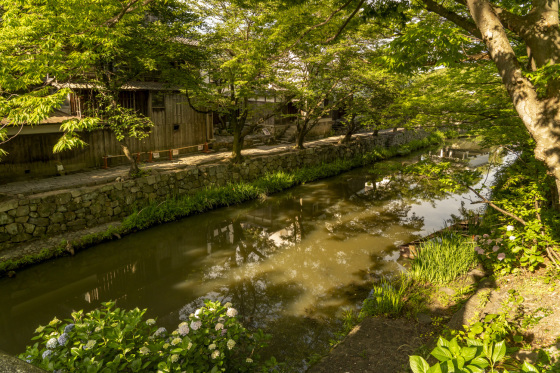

{"left": 0, "top": 132, "right": 380, "bottom": 197}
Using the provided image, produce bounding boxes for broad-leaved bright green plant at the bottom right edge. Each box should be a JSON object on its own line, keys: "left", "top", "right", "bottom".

{"left": 410, "top": 337, "right": 538, "bottom": 373}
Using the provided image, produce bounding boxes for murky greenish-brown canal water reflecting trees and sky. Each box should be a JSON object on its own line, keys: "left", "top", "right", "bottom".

{"left": 0, "top": 144, "right": 508, "bottom": 371}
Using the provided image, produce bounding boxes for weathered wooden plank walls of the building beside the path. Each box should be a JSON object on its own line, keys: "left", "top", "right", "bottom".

{"left": 0, "top": 91, "right": 213, "bottom": 183}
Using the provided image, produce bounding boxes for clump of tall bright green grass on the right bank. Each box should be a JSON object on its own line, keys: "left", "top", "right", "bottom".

{"left": 409, "top": 234, "right": 478, "bottom": 284}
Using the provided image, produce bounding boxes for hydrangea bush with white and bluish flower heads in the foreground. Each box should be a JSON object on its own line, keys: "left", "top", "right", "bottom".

{"left": 19, "top": 301, "right": 268, "bottom": 373}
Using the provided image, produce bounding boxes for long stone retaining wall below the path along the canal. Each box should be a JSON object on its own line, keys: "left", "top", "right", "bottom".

{"left": 0, "top": 132, "right": 426, "bottom": 250}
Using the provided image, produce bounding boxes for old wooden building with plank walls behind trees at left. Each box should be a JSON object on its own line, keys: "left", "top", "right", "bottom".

{"left": 0, "top": 82, "right": 213, "bottom": 184}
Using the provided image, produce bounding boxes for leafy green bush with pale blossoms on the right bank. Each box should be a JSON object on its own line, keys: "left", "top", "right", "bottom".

{"left": 476, "top": 149, "right": 560, "bottom": 273}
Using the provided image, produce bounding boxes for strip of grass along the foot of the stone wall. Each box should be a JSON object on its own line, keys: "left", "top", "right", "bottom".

{"left": 0, "top": 131, "right": 445, "bottom": 275}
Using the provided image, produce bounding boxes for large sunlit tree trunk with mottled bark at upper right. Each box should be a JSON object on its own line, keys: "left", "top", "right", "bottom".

{"left": 467, "top": 0, "right": 560, "bottom": 203}
